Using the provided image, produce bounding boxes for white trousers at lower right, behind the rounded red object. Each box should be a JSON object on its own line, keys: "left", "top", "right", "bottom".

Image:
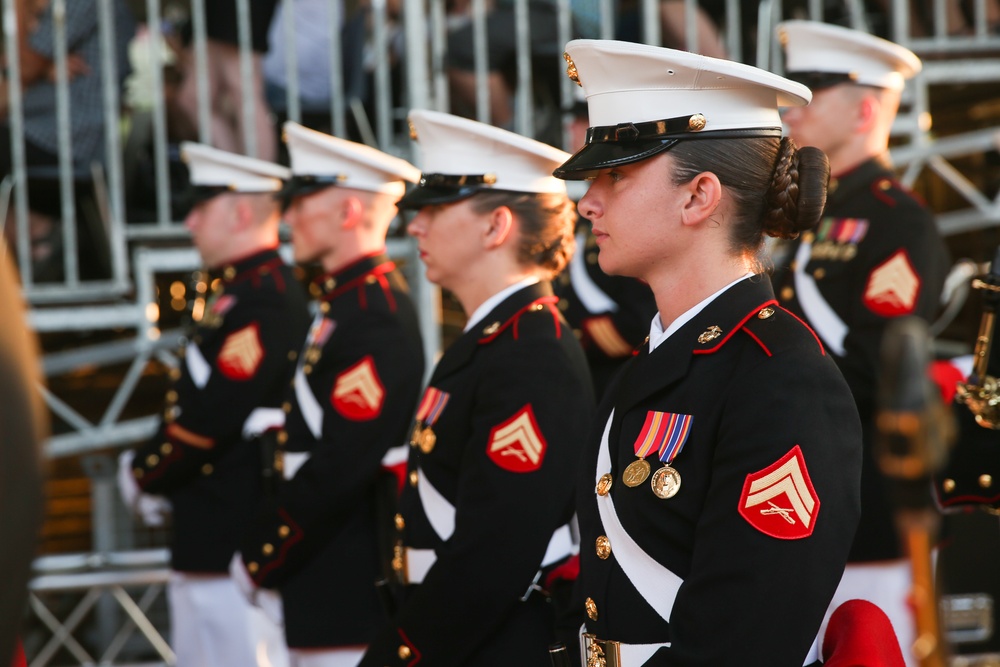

{"left": 819, "top": 559, "right": 919, "bottom": 667}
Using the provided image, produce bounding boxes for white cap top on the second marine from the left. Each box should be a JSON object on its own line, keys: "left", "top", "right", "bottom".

{"left": 282, "top": 121, "right": 420, "bottom": 197}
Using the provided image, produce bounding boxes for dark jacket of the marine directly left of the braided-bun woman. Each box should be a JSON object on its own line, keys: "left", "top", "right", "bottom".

{"left": 361, "top": 282, "right": 593, "bottom": 667}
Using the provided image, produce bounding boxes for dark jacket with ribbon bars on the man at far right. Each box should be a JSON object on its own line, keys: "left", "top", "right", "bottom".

{"left": 773, "top": 159, "right": 949, "bottom": 562}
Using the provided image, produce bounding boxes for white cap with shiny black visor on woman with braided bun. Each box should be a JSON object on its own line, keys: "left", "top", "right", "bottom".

{"left": 556, "top": 39, "right": 812, "bottom": 179}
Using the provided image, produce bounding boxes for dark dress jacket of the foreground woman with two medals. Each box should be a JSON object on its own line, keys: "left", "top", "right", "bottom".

{"left": 577, "top": 276, "right": 861, "bottom": 667}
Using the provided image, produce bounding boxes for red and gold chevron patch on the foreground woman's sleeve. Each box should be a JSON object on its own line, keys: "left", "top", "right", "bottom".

{"left": 739, "top": 445, "right": 819, "bottom": 540}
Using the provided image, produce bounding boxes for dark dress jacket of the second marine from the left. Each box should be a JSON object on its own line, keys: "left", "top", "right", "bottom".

{"left": 242, "top": 255, "right": 424, "bottom": 648}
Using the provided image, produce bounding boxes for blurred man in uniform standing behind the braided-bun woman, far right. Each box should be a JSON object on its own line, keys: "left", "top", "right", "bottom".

{"left": 773, "top": 21, "right": 949, "bottom": 664}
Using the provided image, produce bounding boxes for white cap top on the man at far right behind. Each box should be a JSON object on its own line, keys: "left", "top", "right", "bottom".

{"left": 777, "top": 21, "right": 921, "bottom": 90}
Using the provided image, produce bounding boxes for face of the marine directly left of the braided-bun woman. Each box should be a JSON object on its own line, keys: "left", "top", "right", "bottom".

{"left": 406, "top": 199, "right": 489, "bottom": 291}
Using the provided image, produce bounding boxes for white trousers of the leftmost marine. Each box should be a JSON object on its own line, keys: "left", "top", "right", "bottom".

{"left": 167, "top": 572, "right": 289, "bottom": 667}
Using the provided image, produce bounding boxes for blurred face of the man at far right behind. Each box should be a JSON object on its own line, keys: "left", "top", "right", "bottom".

{"left": 781, "top": 84, "right": 858, "bottom": 166}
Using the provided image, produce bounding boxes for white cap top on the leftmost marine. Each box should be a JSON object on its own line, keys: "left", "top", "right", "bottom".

{"left": 181, "top": 141, "right": 291, "bottom": 192}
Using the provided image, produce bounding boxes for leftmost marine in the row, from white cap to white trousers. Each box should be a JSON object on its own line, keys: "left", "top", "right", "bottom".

{"left": 118, "top": 143, "right": 309, "bottom": 667}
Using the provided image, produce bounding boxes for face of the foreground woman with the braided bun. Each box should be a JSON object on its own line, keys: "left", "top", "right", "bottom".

{"left": 577, "top": 152, "right": 683, "bottom": 280}
